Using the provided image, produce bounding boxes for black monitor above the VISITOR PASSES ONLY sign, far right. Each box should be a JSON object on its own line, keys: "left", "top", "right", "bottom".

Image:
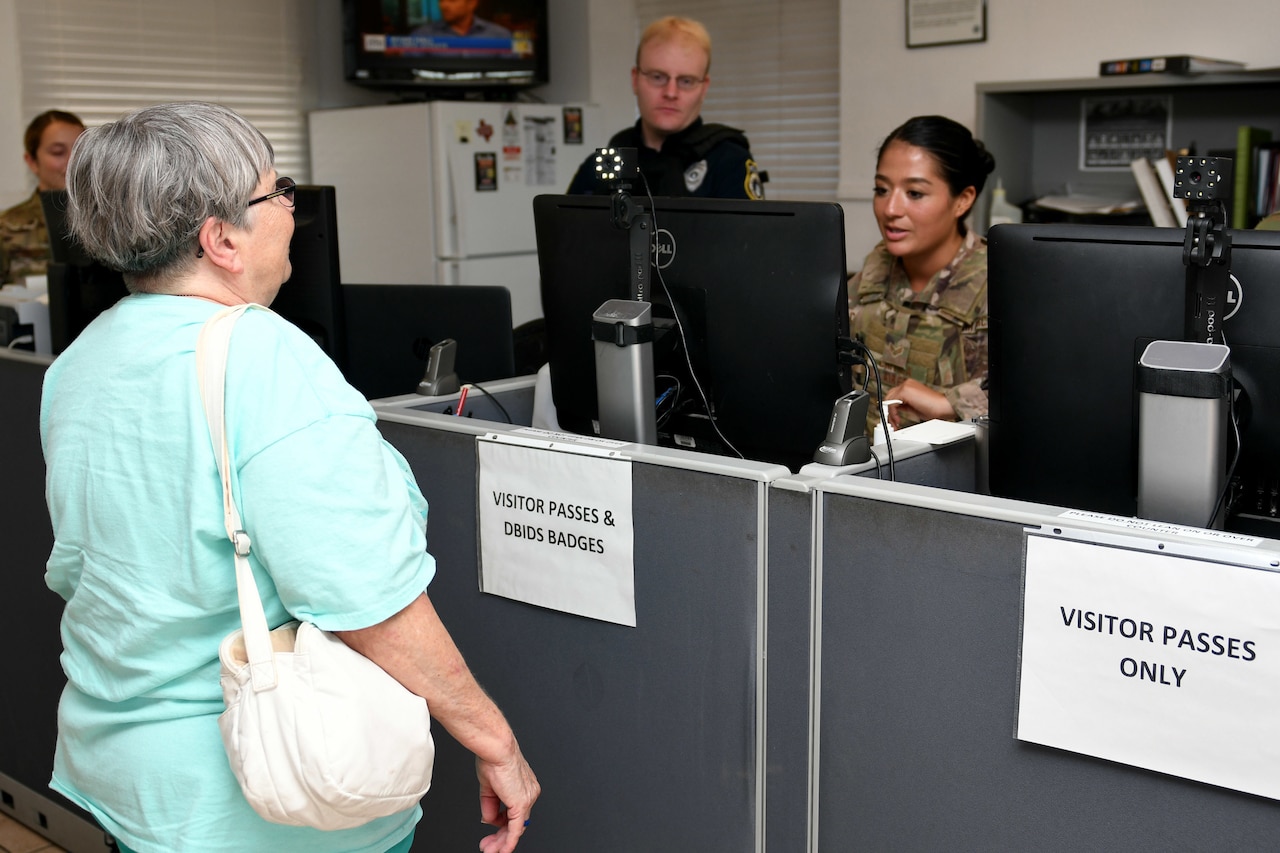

{"left": 987, "top": 224, "right": 1280, "bottom": 537}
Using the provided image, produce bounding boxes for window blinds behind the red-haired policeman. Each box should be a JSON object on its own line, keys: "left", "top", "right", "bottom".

{"left": 636, "top": 0, "right": 840, "bottom": 201}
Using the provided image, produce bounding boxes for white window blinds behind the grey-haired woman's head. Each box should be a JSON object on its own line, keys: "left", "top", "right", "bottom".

{"left": 17, "top": 0, "right": 310, "bottom": 183}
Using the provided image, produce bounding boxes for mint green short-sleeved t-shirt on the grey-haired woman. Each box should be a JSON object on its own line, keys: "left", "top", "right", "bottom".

{"left": 40, "top": 295, "right": 435, "bottom": 853}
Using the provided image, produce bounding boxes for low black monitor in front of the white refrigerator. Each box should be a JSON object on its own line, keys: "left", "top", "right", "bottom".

{"left": 342, "top": 284, "right": 516, "bottom": 400}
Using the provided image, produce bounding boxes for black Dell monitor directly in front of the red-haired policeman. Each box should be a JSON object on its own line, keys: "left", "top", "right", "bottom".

{"left": 534, "top": 196, "right": 849, "bottom": 469}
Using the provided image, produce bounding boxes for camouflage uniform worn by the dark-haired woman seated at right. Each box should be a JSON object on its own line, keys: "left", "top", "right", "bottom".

{"left": 849, "top": 231, "right": 987, "bottom": 433}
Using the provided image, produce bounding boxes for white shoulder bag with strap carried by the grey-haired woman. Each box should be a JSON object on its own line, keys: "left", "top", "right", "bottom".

{"left": 196, "top": 305, "right": 435, "bottom": 830}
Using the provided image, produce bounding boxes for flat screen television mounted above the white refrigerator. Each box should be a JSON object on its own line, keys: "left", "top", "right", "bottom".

{"left": 343, "top": 0, "right": 550, "bottom": 93}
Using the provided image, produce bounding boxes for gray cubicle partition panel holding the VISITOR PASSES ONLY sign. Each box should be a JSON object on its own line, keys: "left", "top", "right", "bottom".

{"left": 808, "top": 478, "right": 1280, "bottom": 853}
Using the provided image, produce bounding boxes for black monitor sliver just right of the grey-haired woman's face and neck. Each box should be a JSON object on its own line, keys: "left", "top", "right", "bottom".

{"left": 271, "top": 186, "right": 347, "bottom": 368}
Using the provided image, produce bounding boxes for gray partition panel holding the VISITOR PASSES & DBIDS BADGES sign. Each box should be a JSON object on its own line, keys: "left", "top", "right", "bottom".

{"left": 375, "top": 400, "right": 793, "bottom": 853}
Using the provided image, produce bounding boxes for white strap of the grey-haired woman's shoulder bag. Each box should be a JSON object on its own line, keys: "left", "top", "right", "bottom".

{"left": 196, "top": 304, "right": 276, "bottom": 692}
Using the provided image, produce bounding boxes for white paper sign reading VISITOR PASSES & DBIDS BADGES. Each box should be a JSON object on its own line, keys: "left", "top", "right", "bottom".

{"left": 476, "top": 437, "right": 636, "bottom": 628}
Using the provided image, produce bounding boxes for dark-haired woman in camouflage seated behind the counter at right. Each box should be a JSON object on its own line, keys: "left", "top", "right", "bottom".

{"left": 849, "top": 115, "right": 996, "bottom": 433}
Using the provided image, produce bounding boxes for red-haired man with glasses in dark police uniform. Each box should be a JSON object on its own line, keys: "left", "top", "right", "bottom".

{"left": 568, "top": 17, "right": 764, "bottom": 199}
